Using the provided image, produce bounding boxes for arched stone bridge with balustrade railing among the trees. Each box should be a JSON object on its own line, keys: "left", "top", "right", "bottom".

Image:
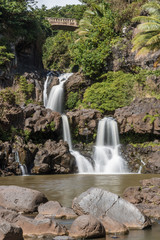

{"left": 46, "top": 17, "right": 78, "bottom": 31}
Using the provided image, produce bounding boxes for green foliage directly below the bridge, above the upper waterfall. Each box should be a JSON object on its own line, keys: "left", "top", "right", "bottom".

{"left": 43, "top": 31, "right": 73, "bottom": 71}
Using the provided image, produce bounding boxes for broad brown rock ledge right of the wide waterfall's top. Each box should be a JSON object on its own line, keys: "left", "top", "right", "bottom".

{"left": 114, "top": 98, "right": 160, "bottom": 135}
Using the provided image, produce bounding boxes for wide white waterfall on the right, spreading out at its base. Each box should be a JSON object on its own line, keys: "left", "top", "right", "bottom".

{"left": 93, "top": 118, "right": 127, "bottom": 173}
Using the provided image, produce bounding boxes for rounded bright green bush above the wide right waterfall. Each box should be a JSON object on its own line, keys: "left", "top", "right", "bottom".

{"left": 82, "top": 71, "right": 135, "bottom": 113}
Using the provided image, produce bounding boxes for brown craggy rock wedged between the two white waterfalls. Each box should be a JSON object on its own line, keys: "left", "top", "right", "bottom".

{"left": 66, "top": 109, "right": 102, "bottom": 142}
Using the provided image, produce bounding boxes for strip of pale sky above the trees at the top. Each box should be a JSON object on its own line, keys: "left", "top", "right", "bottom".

{"left": 37, "top": 0, "right": 81, "bottom": 8}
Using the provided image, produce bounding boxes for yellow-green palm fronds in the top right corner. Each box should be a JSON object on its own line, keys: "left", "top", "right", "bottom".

{"left": 132, "top": 0, "right": 160, "bottom": 64}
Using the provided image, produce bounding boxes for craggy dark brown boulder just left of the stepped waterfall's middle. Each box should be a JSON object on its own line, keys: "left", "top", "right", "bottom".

{"left": 24, "top": 104, "right": 62, "bottom": 141}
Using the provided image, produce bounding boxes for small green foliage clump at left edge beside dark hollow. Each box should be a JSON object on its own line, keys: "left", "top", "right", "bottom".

{"left": 0, "top": 46, "right": 14, "bottom": 69}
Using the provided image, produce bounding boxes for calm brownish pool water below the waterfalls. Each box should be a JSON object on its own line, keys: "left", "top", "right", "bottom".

{"left": 0, "top": 174, "right": 160, "bottom": 240}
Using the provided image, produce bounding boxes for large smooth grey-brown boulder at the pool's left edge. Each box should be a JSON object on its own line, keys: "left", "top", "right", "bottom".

{"left": 0, "top": 186, "right": 47, "bottom": 213}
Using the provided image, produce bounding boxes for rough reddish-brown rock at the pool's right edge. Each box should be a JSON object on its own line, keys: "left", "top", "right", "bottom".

{"left": 123, "top": 178, "right": 160, "bottom": 219}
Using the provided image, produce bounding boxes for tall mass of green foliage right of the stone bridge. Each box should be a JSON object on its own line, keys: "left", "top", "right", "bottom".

{"left": 70, "top": 3, "right": 115, "bottom": 78}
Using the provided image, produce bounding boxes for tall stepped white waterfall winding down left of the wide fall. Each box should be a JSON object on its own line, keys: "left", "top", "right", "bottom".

{"left": 43, "top": 73, "right": 93, "bottom": 173}
